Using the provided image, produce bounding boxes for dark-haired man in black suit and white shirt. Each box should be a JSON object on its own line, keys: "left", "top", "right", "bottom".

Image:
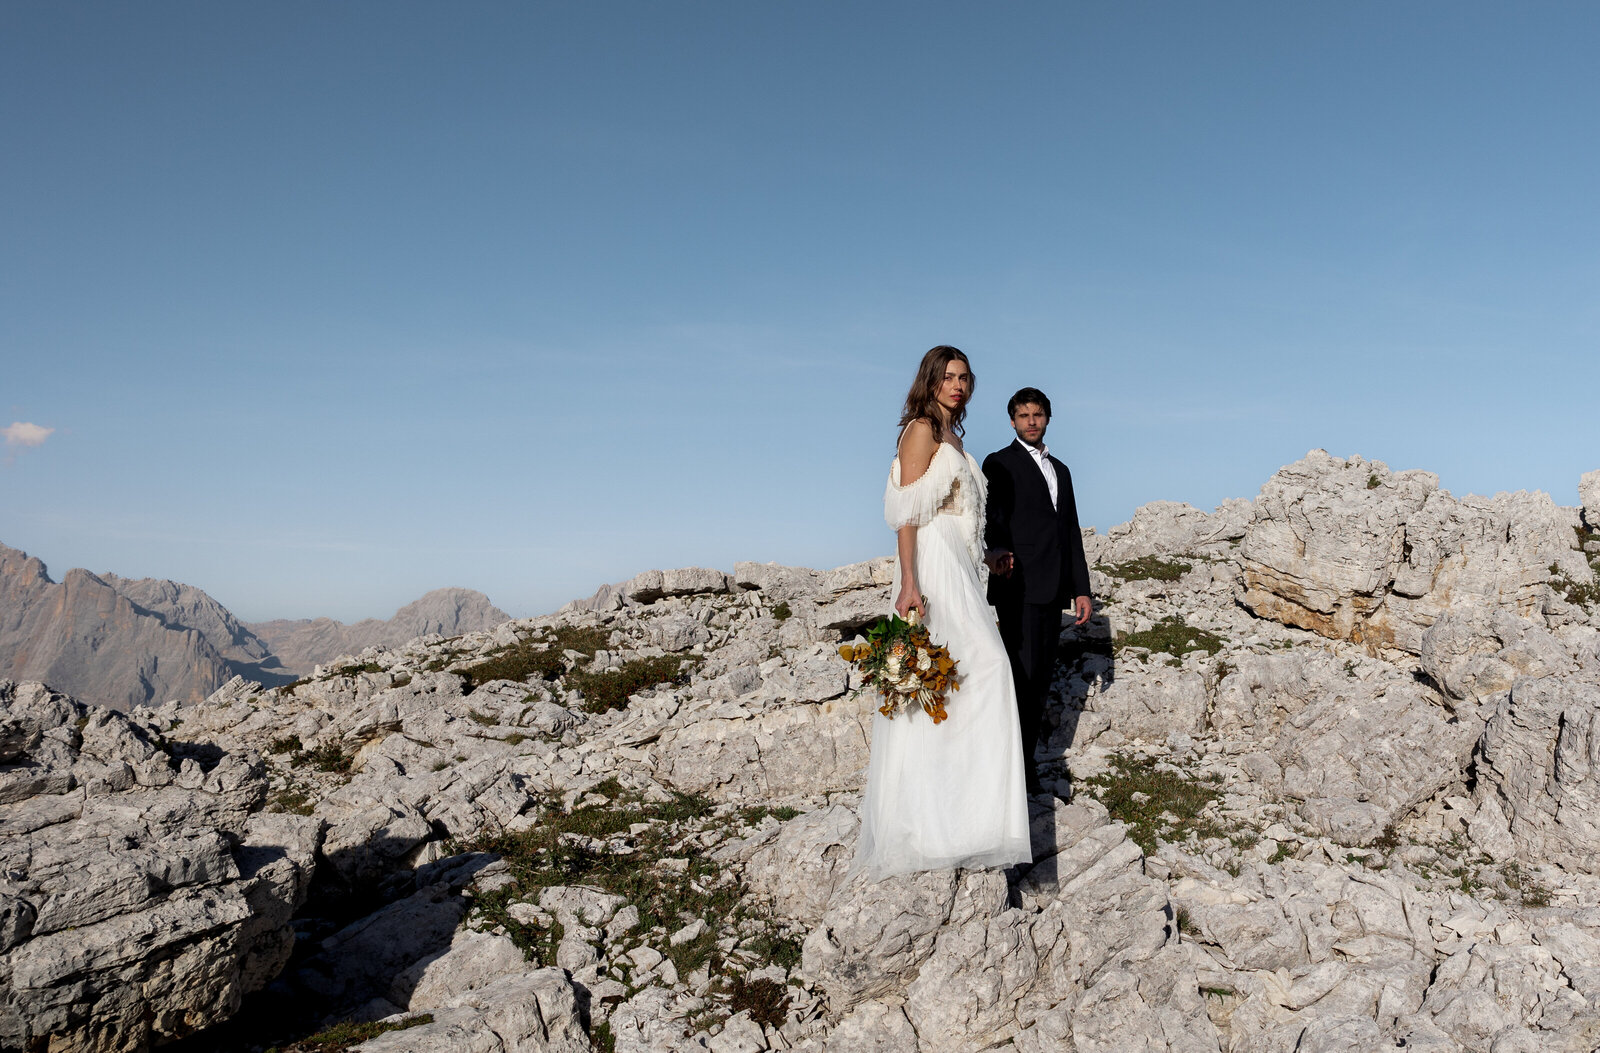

{"left": 984, "top": 387, "right": 1090, "bottom": 794}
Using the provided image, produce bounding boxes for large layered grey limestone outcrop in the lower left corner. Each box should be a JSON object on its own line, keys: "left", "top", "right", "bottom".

{"left": 0, "top": 680, "right": 320, "bottom": 1050}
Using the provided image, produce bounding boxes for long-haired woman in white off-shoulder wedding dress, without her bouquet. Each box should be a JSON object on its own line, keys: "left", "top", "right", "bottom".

{"left": 850, "top": 346, "right": 1034, "bottom": 880}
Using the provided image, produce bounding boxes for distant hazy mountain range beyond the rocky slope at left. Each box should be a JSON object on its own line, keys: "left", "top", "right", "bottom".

{"left": 0, "top": 544, "right": 510, "bottom": 709}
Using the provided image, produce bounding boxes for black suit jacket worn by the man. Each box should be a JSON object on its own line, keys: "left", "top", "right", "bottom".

{"left": 984, "top": 442, "right": 1090, "bottom": 608}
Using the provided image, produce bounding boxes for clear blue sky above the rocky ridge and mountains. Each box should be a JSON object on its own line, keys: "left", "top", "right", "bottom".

{"left": 0, "top": 0, "right": 1600, "bottom": 619}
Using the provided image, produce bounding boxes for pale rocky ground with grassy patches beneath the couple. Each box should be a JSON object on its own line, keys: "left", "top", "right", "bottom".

{"left": 0, "top": 451, "right": 1600, "bottom": 1053}
